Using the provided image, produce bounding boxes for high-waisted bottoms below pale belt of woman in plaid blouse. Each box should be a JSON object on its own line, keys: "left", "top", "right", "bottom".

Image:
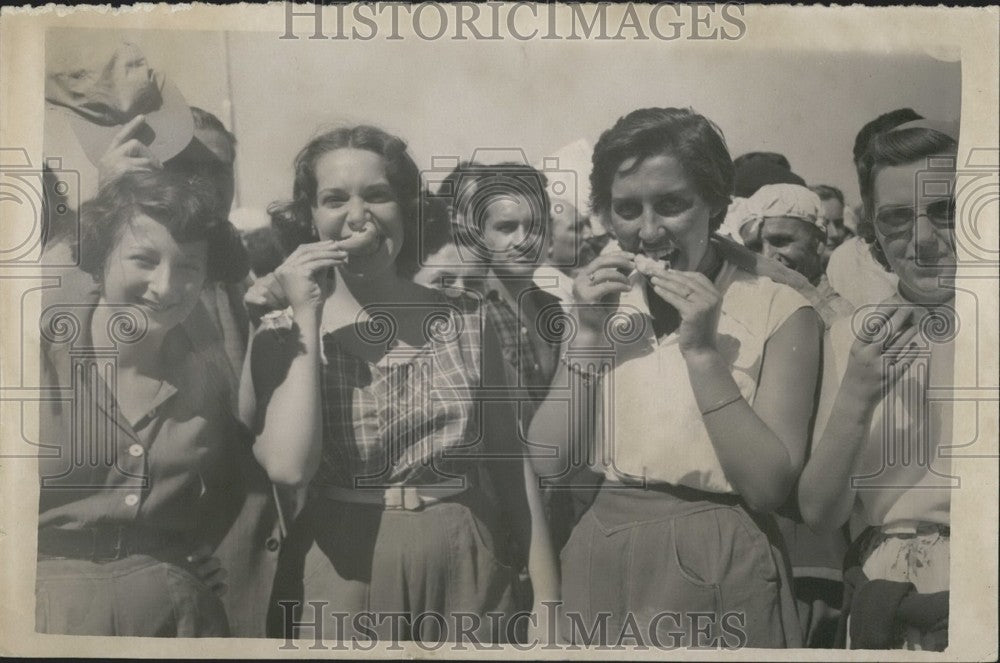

{"left": 270, "top": 488, "right": 524, "bottom": 643}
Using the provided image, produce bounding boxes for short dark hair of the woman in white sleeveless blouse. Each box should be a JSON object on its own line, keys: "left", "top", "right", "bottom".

{"left": 590, "top": 108, "right": 733, "bottom": 232}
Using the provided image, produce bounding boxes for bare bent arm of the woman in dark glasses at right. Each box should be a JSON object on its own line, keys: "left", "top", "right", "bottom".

{"left": 799, "top": 307, "right": 918, "bottom": 531}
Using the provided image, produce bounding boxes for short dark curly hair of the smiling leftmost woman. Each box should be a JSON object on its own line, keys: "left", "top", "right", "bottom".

{"left": 76, "top": 170, "right": 250, "bottom": 283}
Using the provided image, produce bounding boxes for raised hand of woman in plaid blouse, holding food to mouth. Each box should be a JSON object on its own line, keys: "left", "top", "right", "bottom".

{"left": 274, "top": 240, "right": 347, "bottom": 313}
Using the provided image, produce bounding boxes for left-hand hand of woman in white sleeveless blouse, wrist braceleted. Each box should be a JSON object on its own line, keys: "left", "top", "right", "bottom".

{"left": 571, "top": 251, "right": 635, "bottom": 339}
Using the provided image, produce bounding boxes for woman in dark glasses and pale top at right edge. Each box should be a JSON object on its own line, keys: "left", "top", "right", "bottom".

{"left": 799, "top": 120, "right": 957, "bottom": 650}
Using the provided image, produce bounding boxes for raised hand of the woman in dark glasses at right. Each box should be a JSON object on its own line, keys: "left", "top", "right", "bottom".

{"left": 843, "top": 295, "right": 919, "bottom": 404}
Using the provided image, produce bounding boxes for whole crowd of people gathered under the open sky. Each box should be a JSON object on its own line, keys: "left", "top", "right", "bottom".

{"left": 36, "top": 37, "right": 958, "bottom": 650}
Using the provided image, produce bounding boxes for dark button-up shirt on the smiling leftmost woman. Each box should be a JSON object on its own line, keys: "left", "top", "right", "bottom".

{"left": 38, "top": 302, "right": 249, "bottom": 532}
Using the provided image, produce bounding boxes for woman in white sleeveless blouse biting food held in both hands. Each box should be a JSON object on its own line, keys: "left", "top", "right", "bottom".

{"left": 529, "top": 108, "right": 822, "bottom": 647}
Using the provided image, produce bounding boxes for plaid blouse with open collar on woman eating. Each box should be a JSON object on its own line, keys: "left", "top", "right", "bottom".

{"left": 262, "top": 297, "right": 483, "bottom": 488}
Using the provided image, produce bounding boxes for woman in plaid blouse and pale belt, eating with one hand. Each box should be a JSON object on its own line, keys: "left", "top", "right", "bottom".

{"left": 243, "top": 126, "right": 558, "bottom": 641}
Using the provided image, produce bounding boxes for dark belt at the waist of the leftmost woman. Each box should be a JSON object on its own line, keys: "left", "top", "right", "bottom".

{"left": 38, "top": 526, "right": 186, "bottom": 562}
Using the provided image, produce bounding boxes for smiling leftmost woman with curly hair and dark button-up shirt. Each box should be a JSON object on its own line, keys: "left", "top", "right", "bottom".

{"left": 36, "top": 172, "right": 252, "bottom": 637}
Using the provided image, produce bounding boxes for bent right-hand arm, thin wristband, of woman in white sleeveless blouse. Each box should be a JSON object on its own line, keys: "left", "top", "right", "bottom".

{"left": 685, "top": 308, "right": 822, "bottom": 512}
